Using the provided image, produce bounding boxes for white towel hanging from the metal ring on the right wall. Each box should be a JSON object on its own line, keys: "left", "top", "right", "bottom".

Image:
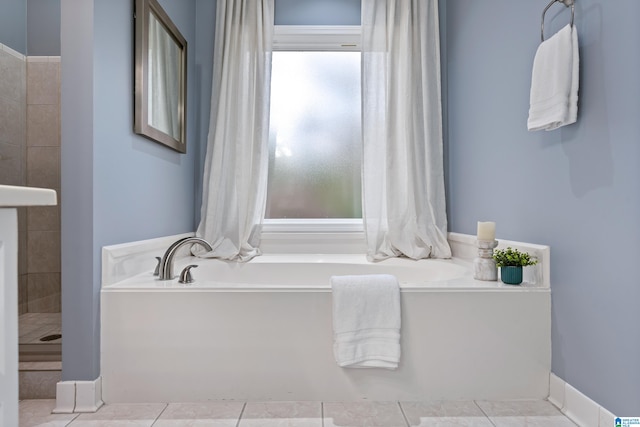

{"left": 527, "top": 25, "right": 580, "bottom": 131}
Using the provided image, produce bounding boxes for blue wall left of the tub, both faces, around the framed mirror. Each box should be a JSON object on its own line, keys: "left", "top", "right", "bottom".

{"left": 61, "top": 0, "right": 200, "bottom": 380}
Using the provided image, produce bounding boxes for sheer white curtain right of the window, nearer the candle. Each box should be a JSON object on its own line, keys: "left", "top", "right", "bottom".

{"left": 362, "top": 0, "right": 451, "bottom": 260}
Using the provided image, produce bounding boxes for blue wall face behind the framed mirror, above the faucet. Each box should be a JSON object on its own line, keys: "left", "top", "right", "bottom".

{"left": 93, "top": 0, "right": 198, "bottom": 246}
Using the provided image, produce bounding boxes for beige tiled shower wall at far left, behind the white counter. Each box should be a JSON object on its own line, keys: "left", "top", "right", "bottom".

{"left": 0, "top": 44, "right": 61, "bottom": 314}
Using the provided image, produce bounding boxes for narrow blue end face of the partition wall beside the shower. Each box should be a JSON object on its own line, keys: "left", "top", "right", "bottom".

{"left": 60, "top": 0, "right": 100, "bottom": 380}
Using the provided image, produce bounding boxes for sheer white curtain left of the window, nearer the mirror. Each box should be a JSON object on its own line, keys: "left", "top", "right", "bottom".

{"left": 196, "top": 0, "right": 274, "bottom": 261}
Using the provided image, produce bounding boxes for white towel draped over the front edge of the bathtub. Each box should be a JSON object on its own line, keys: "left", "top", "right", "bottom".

{"left": 331, "top": 274, "right": 400, "bottom": 369}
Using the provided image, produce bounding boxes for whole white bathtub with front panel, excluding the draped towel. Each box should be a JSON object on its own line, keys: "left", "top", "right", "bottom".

{"left": 101, "top": 234, "right": 551, "bottom": 403}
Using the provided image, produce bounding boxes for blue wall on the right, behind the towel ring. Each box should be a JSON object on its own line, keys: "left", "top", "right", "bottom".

{"left": 443, "top": 0, "right": 640, "bottom": 416}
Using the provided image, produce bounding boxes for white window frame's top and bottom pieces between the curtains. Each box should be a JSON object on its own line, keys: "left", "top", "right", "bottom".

{"left": 262, "top": 25, "right": 364, "bottom": 241}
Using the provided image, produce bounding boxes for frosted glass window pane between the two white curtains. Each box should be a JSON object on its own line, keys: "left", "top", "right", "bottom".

{"left": 266, "top": 52, "right": 362, "bottom": 218}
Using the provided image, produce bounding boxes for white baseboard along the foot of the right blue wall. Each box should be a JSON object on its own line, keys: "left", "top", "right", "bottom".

{"left": 549, "top": 372, "right": 615, "bottom": 427}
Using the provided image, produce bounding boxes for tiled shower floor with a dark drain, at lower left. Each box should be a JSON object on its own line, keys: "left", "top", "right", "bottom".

{"left": 18, "top": 313, "right": 62, "bottom": 362}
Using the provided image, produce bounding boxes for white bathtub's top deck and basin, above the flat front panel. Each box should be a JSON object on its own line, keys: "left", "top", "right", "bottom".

{"left": 111, "top": 254, "right": 476, "bottom": 290}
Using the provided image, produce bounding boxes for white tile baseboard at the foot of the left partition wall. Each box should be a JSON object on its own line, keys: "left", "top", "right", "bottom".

{"left": 53, "top": 377, "right": 104, "bottom": 414}
